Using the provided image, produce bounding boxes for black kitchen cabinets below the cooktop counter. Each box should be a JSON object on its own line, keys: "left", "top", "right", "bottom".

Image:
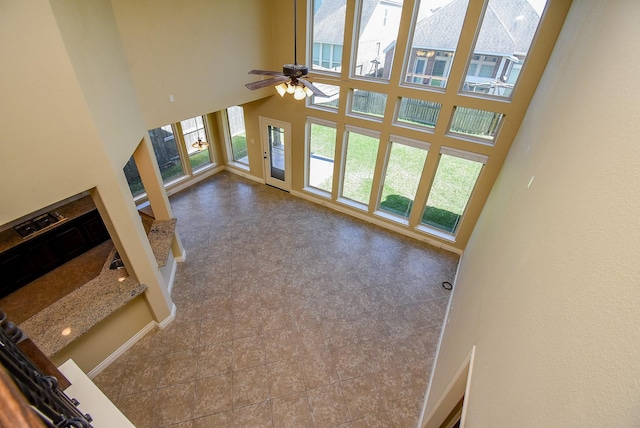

{"left": 0, "top": 210, "right": 109, "bottom": 298}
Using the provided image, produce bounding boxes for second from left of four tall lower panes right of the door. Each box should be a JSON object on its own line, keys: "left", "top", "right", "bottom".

{"left": 341, "top": 131, "right": 379, "bottom": 205}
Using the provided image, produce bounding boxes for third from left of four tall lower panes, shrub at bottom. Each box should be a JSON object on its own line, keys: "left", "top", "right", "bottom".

{"left": 380, "top": 142, "right": 427, "bottom": 219}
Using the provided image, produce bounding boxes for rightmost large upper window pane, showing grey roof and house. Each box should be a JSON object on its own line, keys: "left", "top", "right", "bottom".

{"left": 462, "top": 0, "right": 546, "bottom": 98}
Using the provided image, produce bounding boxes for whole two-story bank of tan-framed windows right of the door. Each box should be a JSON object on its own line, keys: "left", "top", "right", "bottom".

{"left": 302, "top": 0, "right": 570, "bottom": 249}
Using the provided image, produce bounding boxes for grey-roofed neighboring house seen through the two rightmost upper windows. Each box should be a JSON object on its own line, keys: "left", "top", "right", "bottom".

{"left": 385, "top": 0, "right": 540, "bottom": 96}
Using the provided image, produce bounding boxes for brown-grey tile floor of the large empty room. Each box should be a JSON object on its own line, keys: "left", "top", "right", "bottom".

{"left": 94, "top": 172, "right": 458, "bottom": 428}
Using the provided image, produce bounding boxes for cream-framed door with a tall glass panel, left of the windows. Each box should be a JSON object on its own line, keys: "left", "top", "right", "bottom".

{"left": 260, "top": 117, "right": 291, "bottom": 191}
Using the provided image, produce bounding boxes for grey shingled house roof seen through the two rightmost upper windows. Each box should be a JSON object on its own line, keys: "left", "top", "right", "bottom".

{"left": 413, "top": 0, "right": 540, "bottom": 55}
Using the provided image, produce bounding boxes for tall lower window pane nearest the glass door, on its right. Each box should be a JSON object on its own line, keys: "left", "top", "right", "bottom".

{"left": 308, "top": 123, "right": 336, "bottom": 193}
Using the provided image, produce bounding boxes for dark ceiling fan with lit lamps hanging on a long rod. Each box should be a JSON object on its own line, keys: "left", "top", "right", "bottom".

{"left": 245, "top": 0, "right": 328, "bottom": 100}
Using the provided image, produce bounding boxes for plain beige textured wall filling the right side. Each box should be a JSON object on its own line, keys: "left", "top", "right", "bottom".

{"left": 426, "top": 0, "right": 640, "bottom": 428}
